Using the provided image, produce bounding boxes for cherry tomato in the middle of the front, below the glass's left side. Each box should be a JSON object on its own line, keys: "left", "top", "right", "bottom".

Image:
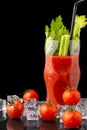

{"left": 39, "top": 102, "right": 58, "bottom": 121}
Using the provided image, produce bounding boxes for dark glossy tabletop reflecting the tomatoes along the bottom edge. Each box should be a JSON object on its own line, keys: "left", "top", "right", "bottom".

{"left": 0, "top": 111, "right": 87, "bottom": 130}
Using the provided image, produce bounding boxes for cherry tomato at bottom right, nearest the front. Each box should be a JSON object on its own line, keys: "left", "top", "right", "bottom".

{"left": 62, "top": 110, "right": 82, "bottom": 128}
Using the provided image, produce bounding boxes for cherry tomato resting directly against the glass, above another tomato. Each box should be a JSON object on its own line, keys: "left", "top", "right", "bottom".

{"left": 62, "top": 88, "right": 81, "bottom": 105}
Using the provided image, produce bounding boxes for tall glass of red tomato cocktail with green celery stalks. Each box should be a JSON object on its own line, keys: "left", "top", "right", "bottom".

{"left": 44, "top": 15, "right": 87, "bottom": 105}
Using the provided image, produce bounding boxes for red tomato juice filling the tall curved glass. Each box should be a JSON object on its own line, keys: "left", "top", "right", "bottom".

{"left": 44, "top": 55, "right": 80, "bottom": 105}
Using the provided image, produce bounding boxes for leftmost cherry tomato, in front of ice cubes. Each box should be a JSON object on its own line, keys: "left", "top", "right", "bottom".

{"left": 6, "top": 99, "right": 24, "bottom": 118}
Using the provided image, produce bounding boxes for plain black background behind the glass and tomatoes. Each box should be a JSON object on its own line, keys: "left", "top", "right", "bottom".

{"left": 0, "top": 0, "right": 87, "bottom": 100}
